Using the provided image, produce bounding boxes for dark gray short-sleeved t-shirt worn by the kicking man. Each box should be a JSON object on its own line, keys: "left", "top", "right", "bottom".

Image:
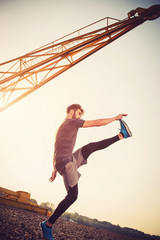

{"left": 54, "top": 118, "right": 85, "bottom": 173}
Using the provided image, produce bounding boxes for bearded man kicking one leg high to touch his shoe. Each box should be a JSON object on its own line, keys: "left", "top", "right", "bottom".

{"left": 41, "top": 104, "right": 132, "bottom": 240}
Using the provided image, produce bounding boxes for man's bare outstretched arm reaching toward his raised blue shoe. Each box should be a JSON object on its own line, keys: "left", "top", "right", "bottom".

{"left": 82, "top": 114, "right": 127, "bottom": 128}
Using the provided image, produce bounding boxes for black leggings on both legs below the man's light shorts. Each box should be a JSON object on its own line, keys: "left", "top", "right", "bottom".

{"left": 48, "top": 135, "right": 119, "bottom": 224}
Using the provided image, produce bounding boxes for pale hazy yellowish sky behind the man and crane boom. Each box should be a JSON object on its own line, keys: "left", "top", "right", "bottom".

{"left": 0, "top": 0, "right": 160, "bottom": 235}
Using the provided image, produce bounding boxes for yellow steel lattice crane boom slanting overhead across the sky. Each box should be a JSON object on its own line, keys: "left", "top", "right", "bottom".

{"left": 0, "top": 5, "right": 160, "bottom": 111}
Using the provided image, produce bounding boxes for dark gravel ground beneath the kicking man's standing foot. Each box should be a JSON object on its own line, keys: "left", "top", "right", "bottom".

{"left": 0, "top": 205, "right": 152, "bottom": 240}
